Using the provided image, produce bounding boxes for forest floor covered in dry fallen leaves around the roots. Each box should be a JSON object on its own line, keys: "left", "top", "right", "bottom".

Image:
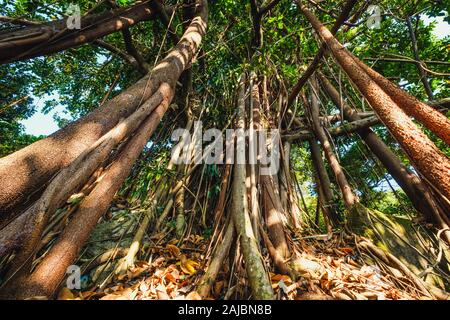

{"left": 58, "top": 199, "right": 426, "bottom": 300}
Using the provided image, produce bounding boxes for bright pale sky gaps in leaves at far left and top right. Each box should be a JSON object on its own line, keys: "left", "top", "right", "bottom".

{"left": 21, "top": 15, "right": 450, "bottom": 135}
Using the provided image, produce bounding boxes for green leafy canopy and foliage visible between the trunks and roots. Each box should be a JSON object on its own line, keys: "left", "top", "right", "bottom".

{"left": 0, "top": 0, "right": 450, "bottom": 223}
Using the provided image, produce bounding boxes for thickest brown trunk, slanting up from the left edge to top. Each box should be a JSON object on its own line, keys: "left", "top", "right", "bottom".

{"left": 0, "top": 0, "right": 206, "bottom": 227}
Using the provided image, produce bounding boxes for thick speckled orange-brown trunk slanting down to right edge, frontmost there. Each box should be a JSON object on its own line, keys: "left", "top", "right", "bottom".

{"left": 300, "top": 6, "right": 450, "bottom": 199}
